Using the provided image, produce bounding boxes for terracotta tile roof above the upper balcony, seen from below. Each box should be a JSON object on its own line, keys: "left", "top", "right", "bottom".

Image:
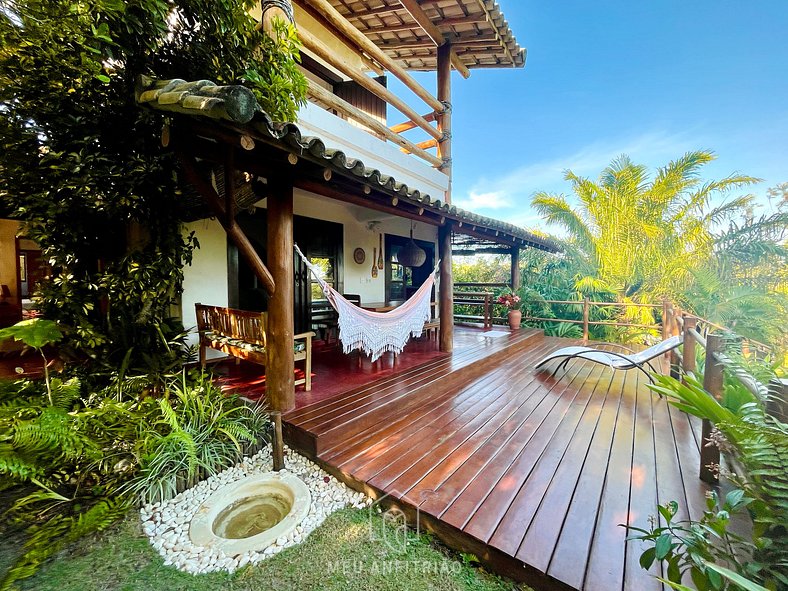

{"left": 331, "top": 0, "right": 526, "bottom": 70}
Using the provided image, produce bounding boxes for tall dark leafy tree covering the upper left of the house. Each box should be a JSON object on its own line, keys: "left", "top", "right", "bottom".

{"left": 0, "top": 0, "right": 306, "bottom": 380}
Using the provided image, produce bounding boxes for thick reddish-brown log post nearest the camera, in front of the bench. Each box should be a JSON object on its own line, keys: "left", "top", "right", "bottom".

{"left": 265, "top": 180, "right": 295, "bottom": 474}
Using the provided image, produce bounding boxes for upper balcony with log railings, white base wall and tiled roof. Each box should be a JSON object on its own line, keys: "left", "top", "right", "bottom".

{"left": 258, "top": 0, "right": 525, "bottom": 201}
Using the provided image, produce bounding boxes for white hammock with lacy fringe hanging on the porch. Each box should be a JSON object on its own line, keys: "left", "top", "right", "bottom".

{"left": 295, "top": 245, "right": 438, "bottom": 361}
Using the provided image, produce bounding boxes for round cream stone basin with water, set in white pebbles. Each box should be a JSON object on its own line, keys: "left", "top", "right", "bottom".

{"left": 189, "top": 472, "right": 312, "bottom": 556}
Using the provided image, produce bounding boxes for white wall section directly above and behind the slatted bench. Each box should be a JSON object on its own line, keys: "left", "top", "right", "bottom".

{"left": 181, "top": 219, "right": 228, "bottom": 359}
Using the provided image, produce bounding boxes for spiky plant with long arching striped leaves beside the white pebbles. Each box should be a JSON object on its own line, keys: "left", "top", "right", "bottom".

{"left": 126, "top": 370, "right": 267, "bottom": 503}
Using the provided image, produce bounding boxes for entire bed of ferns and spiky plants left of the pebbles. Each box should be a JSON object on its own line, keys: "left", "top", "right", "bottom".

{"left": 0, "top": 320, "right": 267, "bottom": 591}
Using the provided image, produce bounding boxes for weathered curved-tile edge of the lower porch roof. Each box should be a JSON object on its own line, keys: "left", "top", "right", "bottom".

{"left": 137, "top": 79, "right": 559, "bottom": 252}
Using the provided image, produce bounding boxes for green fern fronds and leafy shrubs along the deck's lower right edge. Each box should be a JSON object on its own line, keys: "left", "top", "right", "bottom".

{"left": 641, "top": 371, "right": 788, "bottom": 589}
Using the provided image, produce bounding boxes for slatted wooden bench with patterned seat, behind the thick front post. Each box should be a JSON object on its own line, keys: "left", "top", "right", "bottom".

{"left": 195, "top": 304, "right": 315, "bottom": 390}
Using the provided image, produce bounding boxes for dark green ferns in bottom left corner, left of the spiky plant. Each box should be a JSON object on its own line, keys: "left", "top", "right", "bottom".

{"left": 0, "top": 378, "right": 136, "bottom": 590}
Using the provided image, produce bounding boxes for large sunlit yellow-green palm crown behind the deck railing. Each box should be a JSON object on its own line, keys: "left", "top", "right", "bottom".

{"left": 532, "top": 151, "right": 758, "bottom": 310}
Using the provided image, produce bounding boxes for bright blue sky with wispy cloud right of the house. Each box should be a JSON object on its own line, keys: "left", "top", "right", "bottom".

{"left": 398, "top": 0, "right": 788, "bottom": 228}
